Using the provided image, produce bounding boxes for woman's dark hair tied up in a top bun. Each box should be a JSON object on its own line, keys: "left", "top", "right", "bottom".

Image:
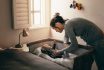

{"left": 50, "top": 13, "right": 65, "bottom": 27}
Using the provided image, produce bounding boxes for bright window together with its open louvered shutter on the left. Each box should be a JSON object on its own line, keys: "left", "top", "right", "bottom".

{"left": 13, "top": 0, "right": 50, "bottom": 29}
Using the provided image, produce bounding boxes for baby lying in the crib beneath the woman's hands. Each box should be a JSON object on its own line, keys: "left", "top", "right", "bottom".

{"left": 34, "top": 44, "right": 62, "bottom": 58}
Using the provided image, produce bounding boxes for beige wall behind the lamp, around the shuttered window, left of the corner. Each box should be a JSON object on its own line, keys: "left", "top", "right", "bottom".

{"left": 0, "top": 0, "right": 50, "bottom": 47}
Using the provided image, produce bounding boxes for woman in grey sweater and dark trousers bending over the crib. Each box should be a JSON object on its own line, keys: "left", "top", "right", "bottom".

{"left": 50, "top": 14, "right": 104, "bottom": 70}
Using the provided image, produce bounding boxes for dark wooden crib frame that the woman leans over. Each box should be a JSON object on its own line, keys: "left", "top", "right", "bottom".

{"left": 28, "top": 39, "right": 93, "bottom": 70}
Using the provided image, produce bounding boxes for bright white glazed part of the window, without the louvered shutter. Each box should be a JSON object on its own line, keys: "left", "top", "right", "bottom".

{"left": 30, "top": 0, "right": 49, "bottom": 28}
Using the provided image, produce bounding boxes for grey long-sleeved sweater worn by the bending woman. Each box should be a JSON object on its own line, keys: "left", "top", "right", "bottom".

{"left": 65, "top": 18, "right": 104, "bottom": 52}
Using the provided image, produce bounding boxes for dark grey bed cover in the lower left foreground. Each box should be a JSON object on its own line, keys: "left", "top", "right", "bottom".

{"left": 0, "top": 49, "right": 69, "bottom": 70}
